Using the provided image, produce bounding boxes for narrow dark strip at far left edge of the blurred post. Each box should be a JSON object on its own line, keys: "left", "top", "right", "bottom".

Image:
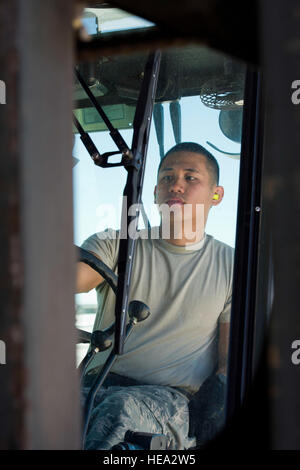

{"left": 0, "top": 0, "right": 25, "bottom": 449}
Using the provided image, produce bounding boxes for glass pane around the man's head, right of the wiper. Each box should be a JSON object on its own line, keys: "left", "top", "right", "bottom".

{"left": 141, "top": 46, "right": 245, "bottom": 247}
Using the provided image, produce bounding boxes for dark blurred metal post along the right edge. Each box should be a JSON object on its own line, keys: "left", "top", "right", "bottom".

{"left": 260, "top": 0, "right": 300, "bottom": 449}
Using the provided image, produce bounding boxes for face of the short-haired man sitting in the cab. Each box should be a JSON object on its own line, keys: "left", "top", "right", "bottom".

{"left": 154, "top": 151, "right": 224, "bottom": 223}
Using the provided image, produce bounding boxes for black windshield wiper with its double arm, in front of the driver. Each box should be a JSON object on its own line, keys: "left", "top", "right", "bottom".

{"left": 74, "top": 51, "right": 161, "bottom": 355}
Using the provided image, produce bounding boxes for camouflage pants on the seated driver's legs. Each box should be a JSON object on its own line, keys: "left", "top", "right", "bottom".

{"left": 83, "top": 376, "right": 195, "bottom": 450}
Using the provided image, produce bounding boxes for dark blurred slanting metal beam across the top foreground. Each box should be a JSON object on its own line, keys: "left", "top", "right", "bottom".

{"left": 87, "top": 0, "right": 259, "bottom": 65}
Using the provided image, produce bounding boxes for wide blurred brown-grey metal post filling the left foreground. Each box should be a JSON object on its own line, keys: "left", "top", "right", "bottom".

{"left": 0, "top": 0, "right": 80, "bottom": 449}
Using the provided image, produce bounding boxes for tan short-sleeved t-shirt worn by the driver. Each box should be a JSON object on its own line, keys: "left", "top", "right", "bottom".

{"left": 82, "top": 227, "right": 234, "bottom": 392}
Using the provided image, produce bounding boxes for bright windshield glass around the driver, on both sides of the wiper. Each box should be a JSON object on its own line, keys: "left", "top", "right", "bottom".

{"left": 73, "top": 41, "right": 245, "bottom": 448}
